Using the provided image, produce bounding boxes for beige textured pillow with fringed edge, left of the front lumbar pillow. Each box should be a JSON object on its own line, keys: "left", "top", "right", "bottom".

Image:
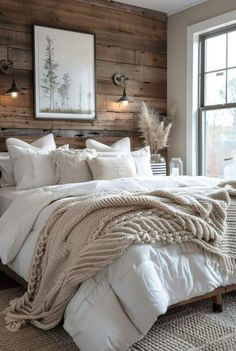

{"left": 51, "top": 149, "right": 96, "bottom": 184}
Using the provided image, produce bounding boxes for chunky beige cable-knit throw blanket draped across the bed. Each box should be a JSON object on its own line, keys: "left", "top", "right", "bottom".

{"left": 5, "top": 184, "right": 236, "bottom": 331}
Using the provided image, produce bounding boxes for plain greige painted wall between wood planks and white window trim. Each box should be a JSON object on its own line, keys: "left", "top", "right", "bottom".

{"left": 167, "top": 0, "right": 236, "bottom": 174}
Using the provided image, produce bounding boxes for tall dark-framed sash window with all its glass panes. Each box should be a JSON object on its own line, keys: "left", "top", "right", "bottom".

{"left": 199, "top": 26, "right": 236, "bottom": 178}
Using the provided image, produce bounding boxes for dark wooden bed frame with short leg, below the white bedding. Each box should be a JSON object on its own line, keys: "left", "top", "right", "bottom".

{"left": 0, "top": 262, "right": 236, "bottom": 313}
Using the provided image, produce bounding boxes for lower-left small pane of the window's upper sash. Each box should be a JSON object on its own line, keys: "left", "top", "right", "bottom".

{"left": 204, "top": 71, "right": 226, "bottom": 106}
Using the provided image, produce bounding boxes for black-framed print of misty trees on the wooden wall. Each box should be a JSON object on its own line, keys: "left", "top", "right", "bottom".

{"left": 34, "top": 26, "right": 96, "bottom": 120}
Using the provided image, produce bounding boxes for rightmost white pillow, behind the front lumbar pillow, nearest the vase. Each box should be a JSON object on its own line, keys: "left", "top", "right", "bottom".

{"left": 97, "top": 146, "right": 153, "bottom": 177}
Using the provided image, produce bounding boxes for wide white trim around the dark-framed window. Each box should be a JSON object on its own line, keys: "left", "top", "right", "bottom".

{"left": 186, "top": 10, "right": 236, "bottom": 175}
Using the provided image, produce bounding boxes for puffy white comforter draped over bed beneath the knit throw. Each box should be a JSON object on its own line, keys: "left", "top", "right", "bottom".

{"left": 0, "top": 177, "right": 236, "bottom": 351}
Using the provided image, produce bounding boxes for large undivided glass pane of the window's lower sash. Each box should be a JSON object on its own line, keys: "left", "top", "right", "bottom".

{"left": 205, "top": 108, "right": 236, "bottom": 178}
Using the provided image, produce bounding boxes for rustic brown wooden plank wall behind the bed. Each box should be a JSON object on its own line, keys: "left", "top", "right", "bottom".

{"left": 0, "top": 0, "right": 167, "bottom": 148}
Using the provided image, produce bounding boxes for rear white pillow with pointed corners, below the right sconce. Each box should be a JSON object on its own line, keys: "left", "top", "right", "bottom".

{"left": 86, "top": 137, "right": 131, "bottom": 153}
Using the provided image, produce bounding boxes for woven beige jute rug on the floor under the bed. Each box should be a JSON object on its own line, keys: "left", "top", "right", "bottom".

{"left": 0, "top": 288, "right": 236, "bottom": 351}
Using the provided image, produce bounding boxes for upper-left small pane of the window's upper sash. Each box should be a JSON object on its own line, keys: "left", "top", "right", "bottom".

{"left": 205, "top": 34, "right": 226, "bottom": 72}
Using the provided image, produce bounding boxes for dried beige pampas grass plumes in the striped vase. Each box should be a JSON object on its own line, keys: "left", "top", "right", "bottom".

{"left": 138, "top": 101, "right": 175, "bottom": 154}
